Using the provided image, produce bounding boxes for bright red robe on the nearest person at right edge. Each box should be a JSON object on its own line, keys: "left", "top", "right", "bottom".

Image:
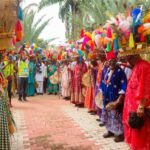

{"left": 123, "top": 60, "right": 150, "bottom": 150}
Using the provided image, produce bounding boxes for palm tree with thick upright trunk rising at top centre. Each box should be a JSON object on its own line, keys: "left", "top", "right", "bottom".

{"left": 39, "top": 0, "right": 85, "bottom": 39}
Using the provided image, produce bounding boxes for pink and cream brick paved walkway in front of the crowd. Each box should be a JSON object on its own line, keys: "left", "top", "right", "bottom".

{"left": 12, "top": 95, "right": 129, "bottom": 150}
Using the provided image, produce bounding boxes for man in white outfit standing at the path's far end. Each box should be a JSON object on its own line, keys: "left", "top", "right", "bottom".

{"left": 35, "top": 59, "right": 45, "bottom": 95}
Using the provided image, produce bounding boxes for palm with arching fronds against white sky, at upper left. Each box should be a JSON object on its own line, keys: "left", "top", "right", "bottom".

{"left": 21, "top": 4, "right": 54, "bottom": 48}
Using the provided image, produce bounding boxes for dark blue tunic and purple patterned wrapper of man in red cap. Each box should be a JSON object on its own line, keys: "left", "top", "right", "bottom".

{"left": 100, "top": 67, "right": 127, "bottom": 135}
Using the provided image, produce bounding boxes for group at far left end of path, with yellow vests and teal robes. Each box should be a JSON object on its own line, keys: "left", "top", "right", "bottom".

{"left": 1, "top": 53, "right": 58, "bottom": 106}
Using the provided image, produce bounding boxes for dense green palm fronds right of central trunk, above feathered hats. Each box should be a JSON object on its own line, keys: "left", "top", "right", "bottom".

{"left": 79, "top": 0, "right": 136, "bottom": 26}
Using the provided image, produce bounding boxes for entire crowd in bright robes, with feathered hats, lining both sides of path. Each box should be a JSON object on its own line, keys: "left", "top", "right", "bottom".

{"left": 0, "top": 1, "right": 150, "bottom": 150}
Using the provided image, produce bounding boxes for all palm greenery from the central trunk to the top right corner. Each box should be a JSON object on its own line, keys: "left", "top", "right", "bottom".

{"left": 40, "top": 0, "right": 150, "bottom": 40}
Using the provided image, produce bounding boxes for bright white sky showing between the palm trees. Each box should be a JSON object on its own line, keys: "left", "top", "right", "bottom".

{"left": 22, "top": 0, "right": 65, "bottom": 43}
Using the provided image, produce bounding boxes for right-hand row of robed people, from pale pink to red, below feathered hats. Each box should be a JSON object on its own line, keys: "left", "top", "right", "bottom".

{"left": 62, "top": 52, "right": 150, "bottom": 150}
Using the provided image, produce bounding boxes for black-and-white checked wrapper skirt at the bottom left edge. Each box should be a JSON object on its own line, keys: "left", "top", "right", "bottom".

{"left": 0, "top": 98, "right": 10, "bottom": 150}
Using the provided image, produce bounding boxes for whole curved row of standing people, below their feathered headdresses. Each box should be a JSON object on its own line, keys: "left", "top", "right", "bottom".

{"left": 1, "top": 47, "right": 150, "bottom": 150}
